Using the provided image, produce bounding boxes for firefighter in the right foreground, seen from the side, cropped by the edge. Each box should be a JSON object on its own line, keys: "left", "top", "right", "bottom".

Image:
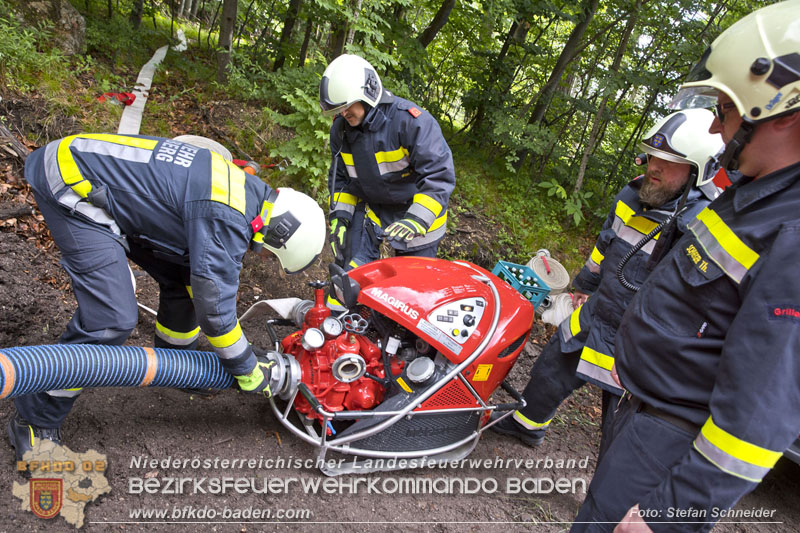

{"left": 574, "top": 0, "right": 800, "bottom": 531}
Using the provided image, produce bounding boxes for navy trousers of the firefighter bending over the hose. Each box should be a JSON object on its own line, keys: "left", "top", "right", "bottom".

{"left": 14, "top": 191, "right": 197, "bottom": 428}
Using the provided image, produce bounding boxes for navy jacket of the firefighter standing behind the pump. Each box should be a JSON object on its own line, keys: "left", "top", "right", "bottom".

{"left": 328, "top": 90, "right": 456, "bottom": 249}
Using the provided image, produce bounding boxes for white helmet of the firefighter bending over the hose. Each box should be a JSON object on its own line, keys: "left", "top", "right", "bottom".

{"left": 264, "top": 187, "right": 327, "bottom": 274}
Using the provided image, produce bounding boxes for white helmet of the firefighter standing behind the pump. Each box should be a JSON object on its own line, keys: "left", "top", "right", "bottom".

{"left": 319, "top": 54, "right": 383, "bottom": 117}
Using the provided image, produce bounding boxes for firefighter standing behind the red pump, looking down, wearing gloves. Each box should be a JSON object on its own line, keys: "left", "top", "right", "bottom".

{"left": 319, "top": 54, "right": 456, "bottom": 270}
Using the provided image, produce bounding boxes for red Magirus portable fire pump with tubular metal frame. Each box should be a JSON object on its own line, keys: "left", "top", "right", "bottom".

{"left": 253, "top": 257, "right": 534, "bottom": 475}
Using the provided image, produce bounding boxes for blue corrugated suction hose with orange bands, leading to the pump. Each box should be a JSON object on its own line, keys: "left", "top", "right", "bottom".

{"left": 0, "top": 344, "right": 233, "bottom": 398}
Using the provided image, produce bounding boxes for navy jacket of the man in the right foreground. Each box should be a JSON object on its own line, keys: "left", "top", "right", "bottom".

{"left": 616, "top": 160, "right": 800, "bottom": 516}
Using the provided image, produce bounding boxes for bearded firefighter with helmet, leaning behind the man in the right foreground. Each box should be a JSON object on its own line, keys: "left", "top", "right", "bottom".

{"left": 492, "top": 109, "right": 723, "bottom": 446}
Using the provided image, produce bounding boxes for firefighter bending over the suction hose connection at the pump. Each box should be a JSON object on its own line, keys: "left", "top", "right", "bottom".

{"left": 8, "top": 134, "right": 326, "bottom": 459}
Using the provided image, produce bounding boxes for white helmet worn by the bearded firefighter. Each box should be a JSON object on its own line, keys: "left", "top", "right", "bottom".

{"left": 639, "top": 109, "right": 724, "bottom": 187}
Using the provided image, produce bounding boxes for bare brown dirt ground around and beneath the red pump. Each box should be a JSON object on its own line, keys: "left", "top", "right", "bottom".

{"left": 0, "top": 107, "right": 800, "bottom": 532}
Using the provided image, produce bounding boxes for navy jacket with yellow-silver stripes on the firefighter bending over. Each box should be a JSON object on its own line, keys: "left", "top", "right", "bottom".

{"left": 25, "top": 134, "right": 272, "bottom": 375}
